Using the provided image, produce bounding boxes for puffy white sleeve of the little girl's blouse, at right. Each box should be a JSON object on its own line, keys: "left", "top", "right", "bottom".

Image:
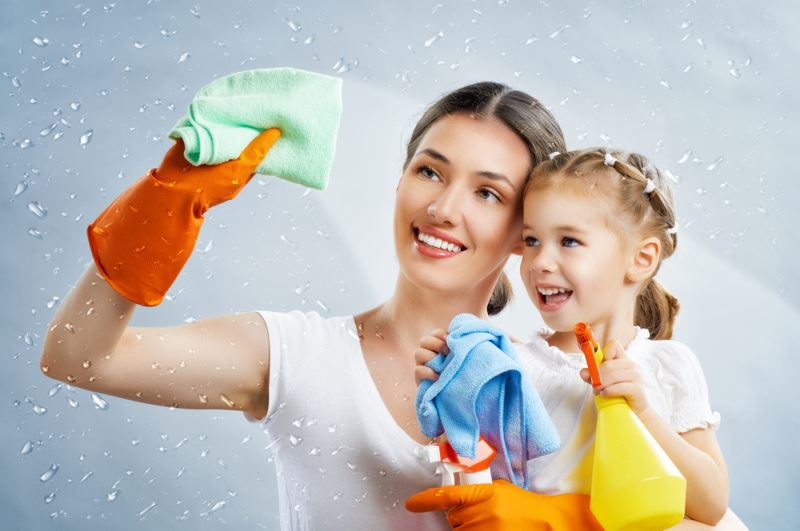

{"left": 654, "top": 341, "right": 720, "bottom": 433}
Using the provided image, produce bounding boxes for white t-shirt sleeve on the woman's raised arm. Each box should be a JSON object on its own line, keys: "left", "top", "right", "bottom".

{"left": 253, "top": 311, "right": 321, "bottom": 424}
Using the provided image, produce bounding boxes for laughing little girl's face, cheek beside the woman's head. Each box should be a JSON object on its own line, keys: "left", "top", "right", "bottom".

{"left": 520, "top": 183, "right": 635, "bottom": 332}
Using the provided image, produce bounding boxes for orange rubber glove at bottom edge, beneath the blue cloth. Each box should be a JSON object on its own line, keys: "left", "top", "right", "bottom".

{"left": 406, "top": 479, "right": 603, "bottom": 531}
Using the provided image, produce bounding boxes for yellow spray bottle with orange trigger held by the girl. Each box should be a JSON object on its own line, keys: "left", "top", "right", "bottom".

{"left": 575, "top": 323, "right": 686, "bottom": 531}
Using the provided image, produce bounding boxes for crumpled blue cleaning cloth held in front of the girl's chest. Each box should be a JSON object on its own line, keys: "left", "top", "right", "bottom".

{"left": 416, "top": 313, "right": 560, "bottom": 488}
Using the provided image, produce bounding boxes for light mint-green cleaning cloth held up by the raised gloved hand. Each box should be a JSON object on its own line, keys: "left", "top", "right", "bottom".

{"left": 169, "top": 68, "right": 342, "bottom": 190}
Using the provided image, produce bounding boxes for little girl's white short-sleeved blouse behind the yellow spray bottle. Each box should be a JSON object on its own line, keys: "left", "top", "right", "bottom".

{"left": 517, "top": 328, "right": 720, "bottom": 494}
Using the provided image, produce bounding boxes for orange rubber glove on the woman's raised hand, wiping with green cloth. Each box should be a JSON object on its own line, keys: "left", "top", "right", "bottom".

{"left": 88, "top": 129, "right": 281, "bottom": 306}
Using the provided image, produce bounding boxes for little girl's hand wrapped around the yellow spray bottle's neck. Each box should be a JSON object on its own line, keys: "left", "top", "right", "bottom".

{"left": 581, "top": 339, "right": 650, "bottom": 416}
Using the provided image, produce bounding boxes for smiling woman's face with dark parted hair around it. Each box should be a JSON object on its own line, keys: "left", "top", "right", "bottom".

{"left": 394, "top": 114, "right": 532, "bottom": 297}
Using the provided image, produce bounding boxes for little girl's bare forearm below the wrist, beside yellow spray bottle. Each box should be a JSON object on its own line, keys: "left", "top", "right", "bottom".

{"left": 639, "top": 409, "right": 728, "bottom": 525}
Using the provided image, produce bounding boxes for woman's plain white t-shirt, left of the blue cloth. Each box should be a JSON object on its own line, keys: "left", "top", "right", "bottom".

{"left": 252, "top": 311, "right": 450, "bottom": 530}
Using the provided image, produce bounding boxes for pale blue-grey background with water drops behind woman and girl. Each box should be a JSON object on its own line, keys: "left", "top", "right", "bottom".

{"left": 0, "top": 0, "right": 800, "bottom": 530}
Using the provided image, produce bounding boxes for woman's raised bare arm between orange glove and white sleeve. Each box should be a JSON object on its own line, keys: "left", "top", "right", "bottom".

{"left": 41, "top": 264, "right": 269, "bottom": 418}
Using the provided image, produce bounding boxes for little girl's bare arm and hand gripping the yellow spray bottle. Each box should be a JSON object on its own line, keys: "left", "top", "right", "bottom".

{"left": 581, "top": 341, "right": 728, "bottom": 525}
